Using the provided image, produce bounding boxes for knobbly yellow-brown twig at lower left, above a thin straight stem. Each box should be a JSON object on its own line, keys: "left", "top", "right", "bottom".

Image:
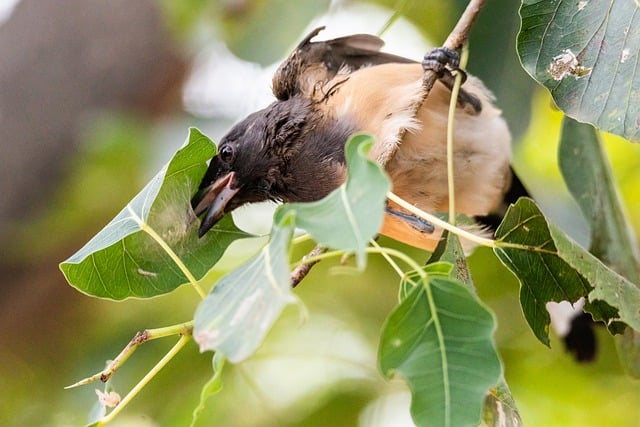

{"left": 65, "top": 320, "right": 193, "bottom": 389}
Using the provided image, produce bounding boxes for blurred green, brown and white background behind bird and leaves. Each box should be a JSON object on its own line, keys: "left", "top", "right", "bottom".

{"left": 0, "top": 0, "right": 640, "bottom": 426}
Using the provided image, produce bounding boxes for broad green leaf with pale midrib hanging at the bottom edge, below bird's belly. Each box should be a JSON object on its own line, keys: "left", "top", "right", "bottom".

{"left": 379, "top": 274, "right": 502, "bottom": 426}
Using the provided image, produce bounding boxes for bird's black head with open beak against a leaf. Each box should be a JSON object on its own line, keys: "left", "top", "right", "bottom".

{"left": 192, "top": 98, "right": 311, "bottom": 236}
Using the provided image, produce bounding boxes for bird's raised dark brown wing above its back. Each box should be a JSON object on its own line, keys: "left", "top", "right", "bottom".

{"left": 272, "top": 27, "right": 415, "bottom": 100}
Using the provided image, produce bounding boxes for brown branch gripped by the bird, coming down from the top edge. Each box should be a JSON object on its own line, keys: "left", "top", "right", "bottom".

{"left": 291, "top": 0, "right": 486, "bottom": 288}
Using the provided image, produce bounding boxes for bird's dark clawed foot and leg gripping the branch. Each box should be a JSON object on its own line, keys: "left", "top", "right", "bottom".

{"left": 422, "top": 47, "right": 482, "bottom": 113}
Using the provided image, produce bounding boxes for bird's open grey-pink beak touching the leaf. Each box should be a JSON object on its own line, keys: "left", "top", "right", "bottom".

{"left": 194, "top": 172, "right": 240, "bottom": 237}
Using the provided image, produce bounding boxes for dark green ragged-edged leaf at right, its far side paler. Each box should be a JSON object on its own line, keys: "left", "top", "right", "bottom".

{"left": 494, "top": 198, "right": 640, "bottom": 345}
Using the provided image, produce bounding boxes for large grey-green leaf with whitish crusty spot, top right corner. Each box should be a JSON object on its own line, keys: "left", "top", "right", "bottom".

{"left": 518, "top": 0, "right": 640, "bottom": 142}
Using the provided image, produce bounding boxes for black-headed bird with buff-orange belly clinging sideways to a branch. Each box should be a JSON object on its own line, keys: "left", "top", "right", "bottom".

{"left": 192, "top": 27, "right": 527, "bottom": 251}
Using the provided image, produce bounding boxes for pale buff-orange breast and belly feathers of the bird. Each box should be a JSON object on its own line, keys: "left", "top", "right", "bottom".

{"left": 327, "top": 64, "right": 511, "bottom": 249}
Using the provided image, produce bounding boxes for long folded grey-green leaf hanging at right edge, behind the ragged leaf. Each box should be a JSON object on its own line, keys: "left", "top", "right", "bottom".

{"left": 558, "top": 117, "right": 640, "bottom": 378}
